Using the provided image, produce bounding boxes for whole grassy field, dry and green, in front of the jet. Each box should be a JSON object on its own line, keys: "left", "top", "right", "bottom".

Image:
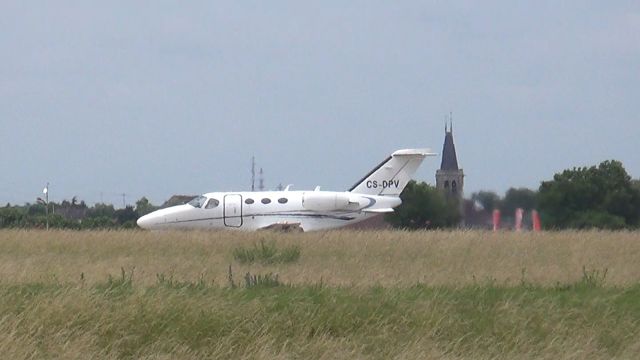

{"left": 0, "top": 231, "right": 640, "bottom": 359}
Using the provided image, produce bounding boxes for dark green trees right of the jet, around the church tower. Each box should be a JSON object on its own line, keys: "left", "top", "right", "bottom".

{"left": 386, "top": 160, "right": 640, "bottom": 230}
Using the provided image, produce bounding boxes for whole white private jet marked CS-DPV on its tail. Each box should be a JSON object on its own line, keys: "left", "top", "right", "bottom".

{"left": 138, "top": 149, "right": 435, "bottom": 231}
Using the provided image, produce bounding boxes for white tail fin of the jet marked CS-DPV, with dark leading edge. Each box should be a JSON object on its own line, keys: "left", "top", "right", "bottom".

{"left": 349, "top": 149, "right": 436, "bottom": 196}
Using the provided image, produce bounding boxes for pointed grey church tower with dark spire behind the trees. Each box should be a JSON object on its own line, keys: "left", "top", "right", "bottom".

{"left": 436, "top": 122, "right": 464, "bottom": 200}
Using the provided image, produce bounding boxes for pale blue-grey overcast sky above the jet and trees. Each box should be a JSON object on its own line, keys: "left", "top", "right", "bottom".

{"left": 0, "top": 0, "right": 640, "bottom": 204}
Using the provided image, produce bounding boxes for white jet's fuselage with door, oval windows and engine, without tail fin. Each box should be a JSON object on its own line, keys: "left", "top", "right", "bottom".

{"left": 138, "top": 191, "right": 401, "bottom": 231}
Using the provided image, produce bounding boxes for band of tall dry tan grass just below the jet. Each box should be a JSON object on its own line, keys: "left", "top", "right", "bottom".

{"left": 0, "top": 230, "right": 640, "bottom": 286}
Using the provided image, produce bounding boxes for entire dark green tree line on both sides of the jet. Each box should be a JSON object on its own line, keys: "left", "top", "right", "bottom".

{"left": 0, "top": 160, "right": 640, "bottom": 230}
